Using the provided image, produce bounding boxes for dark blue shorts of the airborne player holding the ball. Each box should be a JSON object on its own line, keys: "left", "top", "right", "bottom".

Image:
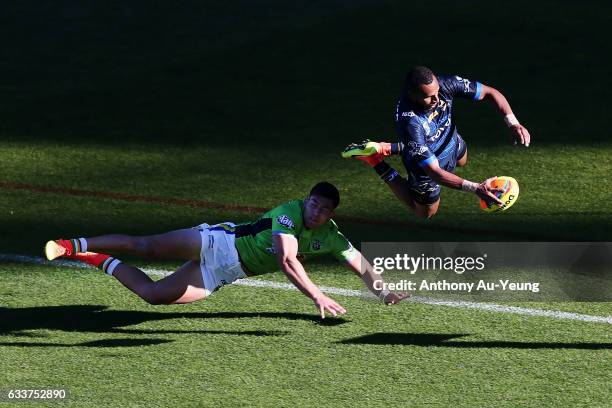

{"left": 406, "top": 134, "right": 467, "bottom": 205}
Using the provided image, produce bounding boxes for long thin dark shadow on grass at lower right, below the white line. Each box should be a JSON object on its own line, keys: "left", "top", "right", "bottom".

{"left": 338, "top": 333, "right": 612, "bottom": 350}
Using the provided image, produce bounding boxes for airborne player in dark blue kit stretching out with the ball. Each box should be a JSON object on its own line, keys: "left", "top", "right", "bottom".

{"left": 342, "top": 67, "right": 531, "bottom": 218}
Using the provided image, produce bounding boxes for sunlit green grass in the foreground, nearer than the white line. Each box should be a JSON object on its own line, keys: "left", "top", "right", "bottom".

{"left": 0, "top": 264, "right": 612, "bottom": 407}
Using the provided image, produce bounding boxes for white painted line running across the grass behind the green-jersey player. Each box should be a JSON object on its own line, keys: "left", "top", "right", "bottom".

{"left": 0, "top": 254, "right": 612, "bottom": 324}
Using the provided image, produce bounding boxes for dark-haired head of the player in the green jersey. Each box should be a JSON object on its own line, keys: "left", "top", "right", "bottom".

{"left": 304, "top": 181, "right": 340, "bottom": 228}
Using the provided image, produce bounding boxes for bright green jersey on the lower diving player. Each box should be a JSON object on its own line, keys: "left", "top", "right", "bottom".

{"left": 235, "top": 200, "right": 357, "bottom": 275}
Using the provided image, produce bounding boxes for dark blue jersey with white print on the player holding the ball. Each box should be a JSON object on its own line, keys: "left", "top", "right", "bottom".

{"left": 395, "top": 75, "right": 482, "bottom": 174}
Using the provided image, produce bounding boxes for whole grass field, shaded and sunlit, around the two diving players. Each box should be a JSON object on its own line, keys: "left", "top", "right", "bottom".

{"left": 0, "top": 0, "right": 612, "bottom": 407}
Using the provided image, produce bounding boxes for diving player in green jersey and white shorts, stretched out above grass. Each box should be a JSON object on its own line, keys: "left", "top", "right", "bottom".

{"left": 45, "top": 182, "right": 407, "bottom": 318}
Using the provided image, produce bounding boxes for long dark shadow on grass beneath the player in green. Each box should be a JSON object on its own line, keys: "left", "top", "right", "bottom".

{"left": 0, "top": 305, "right": 347, "bottom": 336}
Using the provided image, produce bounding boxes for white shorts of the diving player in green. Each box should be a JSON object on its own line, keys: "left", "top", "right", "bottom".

{"left": 194, "top": 222, "right": 246, "bottom": 297}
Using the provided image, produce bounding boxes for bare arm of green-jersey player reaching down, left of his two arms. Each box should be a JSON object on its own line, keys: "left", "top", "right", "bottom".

{"left": 272, "top": 234, "right": 346, "bottom": 319}
